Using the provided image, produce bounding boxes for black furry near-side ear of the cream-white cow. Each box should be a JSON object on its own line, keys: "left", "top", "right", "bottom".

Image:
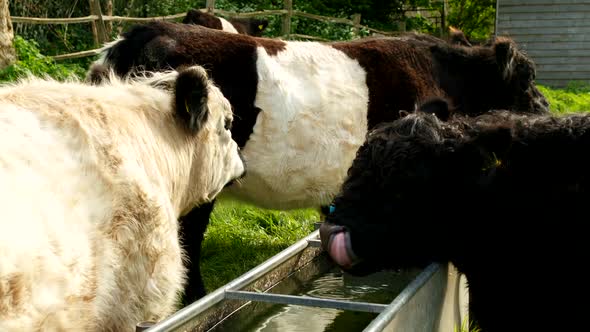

{"left": 174, "top": 66, "right": 209, "bottom": 133}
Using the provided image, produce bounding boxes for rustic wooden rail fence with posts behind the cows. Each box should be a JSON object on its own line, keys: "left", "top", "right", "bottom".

{"left": 11, "top": 0, "right": 408, "bottom": 60}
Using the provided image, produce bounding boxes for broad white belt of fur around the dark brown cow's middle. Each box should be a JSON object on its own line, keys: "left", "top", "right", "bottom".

{"left": 222, "top": 42, "right": 369, "bottom": 209}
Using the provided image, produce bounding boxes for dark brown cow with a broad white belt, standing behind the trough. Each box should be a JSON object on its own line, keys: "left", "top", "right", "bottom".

{"left": 90, "top": 22, "right": 549, "bottom": 301}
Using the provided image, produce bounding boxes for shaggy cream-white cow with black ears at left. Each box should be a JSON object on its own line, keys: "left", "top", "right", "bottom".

{"left": 0, "top": 66, "right": 244, "bottom": 332}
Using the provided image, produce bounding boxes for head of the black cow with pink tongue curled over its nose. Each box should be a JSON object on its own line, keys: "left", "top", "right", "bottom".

{"left": 320, "top": 113, "right": 442, "bottom": 275}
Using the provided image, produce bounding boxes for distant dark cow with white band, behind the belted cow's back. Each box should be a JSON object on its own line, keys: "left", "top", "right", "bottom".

{"left": 182, "top": 9, "right": 268, "bottom": 37}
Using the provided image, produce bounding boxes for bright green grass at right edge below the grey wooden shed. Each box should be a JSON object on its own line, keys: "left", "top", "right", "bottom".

{"left": 537, "top": 83, "right": 590, "bottom": 114}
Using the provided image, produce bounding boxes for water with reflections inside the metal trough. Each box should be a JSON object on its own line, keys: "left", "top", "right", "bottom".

{"left": 212, "top": 268, "right": 420, "bottom": 332}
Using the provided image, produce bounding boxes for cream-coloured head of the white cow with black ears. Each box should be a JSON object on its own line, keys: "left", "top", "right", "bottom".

{"left": 88, "top": 64, "right": 245, "bottom": 212}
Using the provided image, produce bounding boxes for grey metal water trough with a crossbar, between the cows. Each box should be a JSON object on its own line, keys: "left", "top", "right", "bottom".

{"left": 136, "top": 230, "right": 468, "bottom": 332}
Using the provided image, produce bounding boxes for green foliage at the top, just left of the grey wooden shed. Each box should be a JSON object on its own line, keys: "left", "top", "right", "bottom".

{"left": 447, "top": 0, "right": 496, "bottom": 40}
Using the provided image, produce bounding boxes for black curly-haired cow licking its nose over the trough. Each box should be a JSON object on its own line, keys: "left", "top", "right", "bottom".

{"left": 320, "top": 98, "right": 590, "bottom": 332}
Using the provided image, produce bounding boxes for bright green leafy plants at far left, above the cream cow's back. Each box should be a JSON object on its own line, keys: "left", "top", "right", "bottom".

{"left": 0, "top": 36, "right": 86, "bottom": 82}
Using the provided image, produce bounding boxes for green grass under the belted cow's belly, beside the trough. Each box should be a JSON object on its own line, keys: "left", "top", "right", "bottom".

{"left": 201, "top": 200, "right": 320, "bottom": 292}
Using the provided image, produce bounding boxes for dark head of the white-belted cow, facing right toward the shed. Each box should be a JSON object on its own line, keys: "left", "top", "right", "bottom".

{"left": 431, "top": 37, "right": 549, "bottom": 115}
